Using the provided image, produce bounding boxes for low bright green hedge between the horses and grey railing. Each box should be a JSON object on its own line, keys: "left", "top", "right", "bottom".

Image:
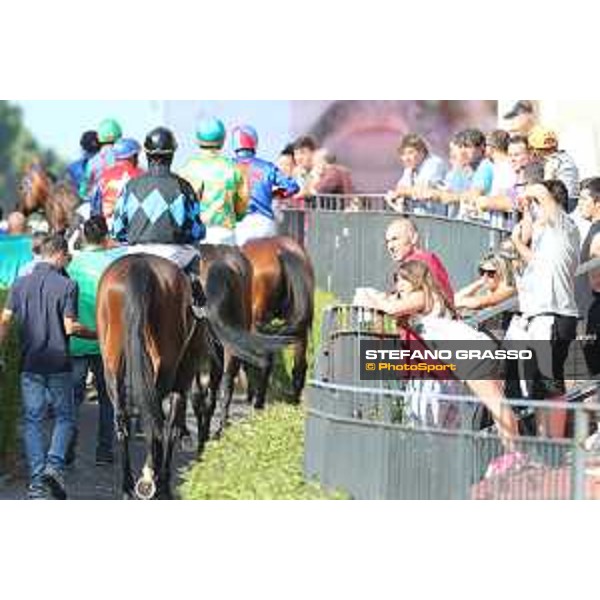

{"left": 180, "top": 403, "right": 346, "bottom": 500}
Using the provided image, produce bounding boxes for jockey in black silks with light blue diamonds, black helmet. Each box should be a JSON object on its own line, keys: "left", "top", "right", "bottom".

{"left": 112, "top": 127, "right": 206, "bottom": 314}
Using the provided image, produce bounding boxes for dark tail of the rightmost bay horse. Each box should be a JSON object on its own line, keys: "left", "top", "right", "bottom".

{"left": 277, "top": 250, "right": 315, "bottom": 336}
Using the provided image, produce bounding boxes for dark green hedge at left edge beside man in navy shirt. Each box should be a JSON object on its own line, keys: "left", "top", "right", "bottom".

{"left": 0, "top": 288, "right": 21, "bottom": 471}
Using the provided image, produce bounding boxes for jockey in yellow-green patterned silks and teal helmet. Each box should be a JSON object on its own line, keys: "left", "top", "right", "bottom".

{"left": 180, "top": 118, "right": 247, "bottom": 245}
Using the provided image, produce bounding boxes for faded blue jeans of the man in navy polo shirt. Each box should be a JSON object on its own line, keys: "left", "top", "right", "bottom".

{"left": 21, "top": 372, "right": 74, "bottom": 484}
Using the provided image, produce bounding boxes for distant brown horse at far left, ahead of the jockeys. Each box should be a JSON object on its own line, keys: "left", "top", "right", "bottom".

{"left": 18, "top": 160, "right": 80, "bottom": 233}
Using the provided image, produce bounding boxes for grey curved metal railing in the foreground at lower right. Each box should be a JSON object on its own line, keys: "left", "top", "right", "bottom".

{"left": 305, "top": 382, "right": 600, "bottom": 500}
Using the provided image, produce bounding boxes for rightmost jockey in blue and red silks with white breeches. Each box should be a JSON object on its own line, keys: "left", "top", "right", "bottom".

{"left": 233, "top": 125, "right": 300, "bottom": 246}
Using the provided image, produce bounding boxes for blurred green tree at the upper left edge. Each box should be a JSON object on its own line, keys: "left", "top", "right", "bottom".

{"left": 0, "top": 100, "right": 65, "bottom": 210}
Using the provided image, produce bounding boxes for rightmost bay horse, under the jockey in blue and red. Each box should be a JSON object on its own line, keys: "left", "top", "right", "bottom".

{"left": 242, "top": 236, "right": 315, "bottom": 408}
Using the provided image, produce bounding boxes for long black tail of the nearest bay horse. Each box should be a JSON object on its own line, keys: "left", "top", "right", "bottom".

{"left": 123, "top": 259, "right": 163, "bottom": 431}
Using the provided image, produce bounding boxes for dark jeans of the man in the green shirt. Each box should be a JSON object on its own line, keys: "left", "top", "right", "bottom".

{"left": 72, "top": 354, "right": 115, "bottom": 456}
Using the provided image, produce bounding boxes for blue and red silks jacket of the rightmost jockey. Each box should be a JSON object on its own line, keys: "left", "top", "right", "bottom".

{"left": 235, "top": 152, "right": 300, "bottom": 220}
